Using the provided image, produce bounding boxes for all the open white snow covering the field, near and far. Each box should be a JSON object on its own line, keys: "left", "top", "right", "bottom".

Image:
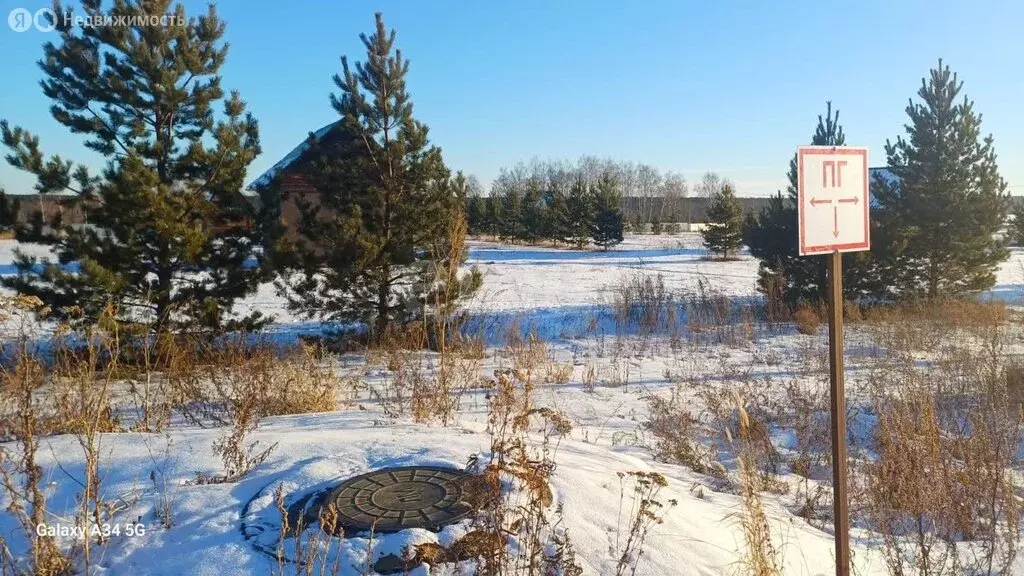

{"left": 0, "top": 230, "right": 1024, "bottom": 576}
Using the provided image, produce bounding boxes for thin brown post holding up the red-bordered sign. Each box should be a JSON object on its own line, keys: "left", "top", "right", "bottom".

{"left": 828, "top": 252, "right": 850, "bottom": 576}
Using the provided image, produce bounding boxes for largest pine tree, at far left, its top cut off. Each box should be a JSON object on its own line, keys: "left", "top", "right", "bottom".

{"left": 0, "top": 0, "right": 266, "bottom": 331}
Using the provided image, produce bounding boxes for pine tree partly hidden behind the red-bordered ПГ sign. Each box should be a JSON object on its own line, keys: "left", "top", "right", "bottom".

{"left": 743, "top": 102, "right": 874, "bottom": 305}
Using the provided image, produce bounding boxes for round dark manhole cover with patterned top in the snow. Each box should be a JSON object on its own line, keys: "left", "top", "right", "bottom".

{"left": 324, "top": 466, "right": 472, "bottom": 532}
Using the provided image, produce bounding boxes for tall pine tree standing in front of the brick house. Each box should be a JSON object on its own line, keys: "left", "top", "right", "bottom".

{"left": 279, "top": 13, "right": 474, "bottom": 339}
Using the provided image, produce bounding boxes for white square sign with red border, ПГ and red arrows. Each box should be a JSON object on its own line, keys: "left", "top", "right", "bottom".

{"left": 797, "top": 146, "right": 870, "bottom": 255}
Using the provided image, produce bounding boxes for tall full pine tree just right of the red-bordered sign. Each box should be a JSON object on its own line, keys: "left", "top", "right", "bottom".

{"left": 874, "top": 60, "right": 1010, "bottom": 298}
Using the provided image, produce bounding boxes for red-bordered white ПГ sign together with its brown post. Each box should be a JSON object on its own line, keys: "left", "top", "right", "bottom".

{"left": 797, "top": 147, "right": 870, "bottom": 576}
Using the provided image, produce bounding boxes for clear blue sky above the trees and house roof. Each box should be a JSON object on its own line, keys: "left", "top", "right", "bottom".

{"left": 0, "top": 0, "right": 1024, "bottom": 196}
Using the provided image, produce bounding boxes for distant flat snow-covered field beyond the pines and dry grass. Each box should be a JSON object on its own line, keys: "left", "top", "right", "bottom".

{"left": 6, "top": 233, "right": 1024, "bottom": 327}
